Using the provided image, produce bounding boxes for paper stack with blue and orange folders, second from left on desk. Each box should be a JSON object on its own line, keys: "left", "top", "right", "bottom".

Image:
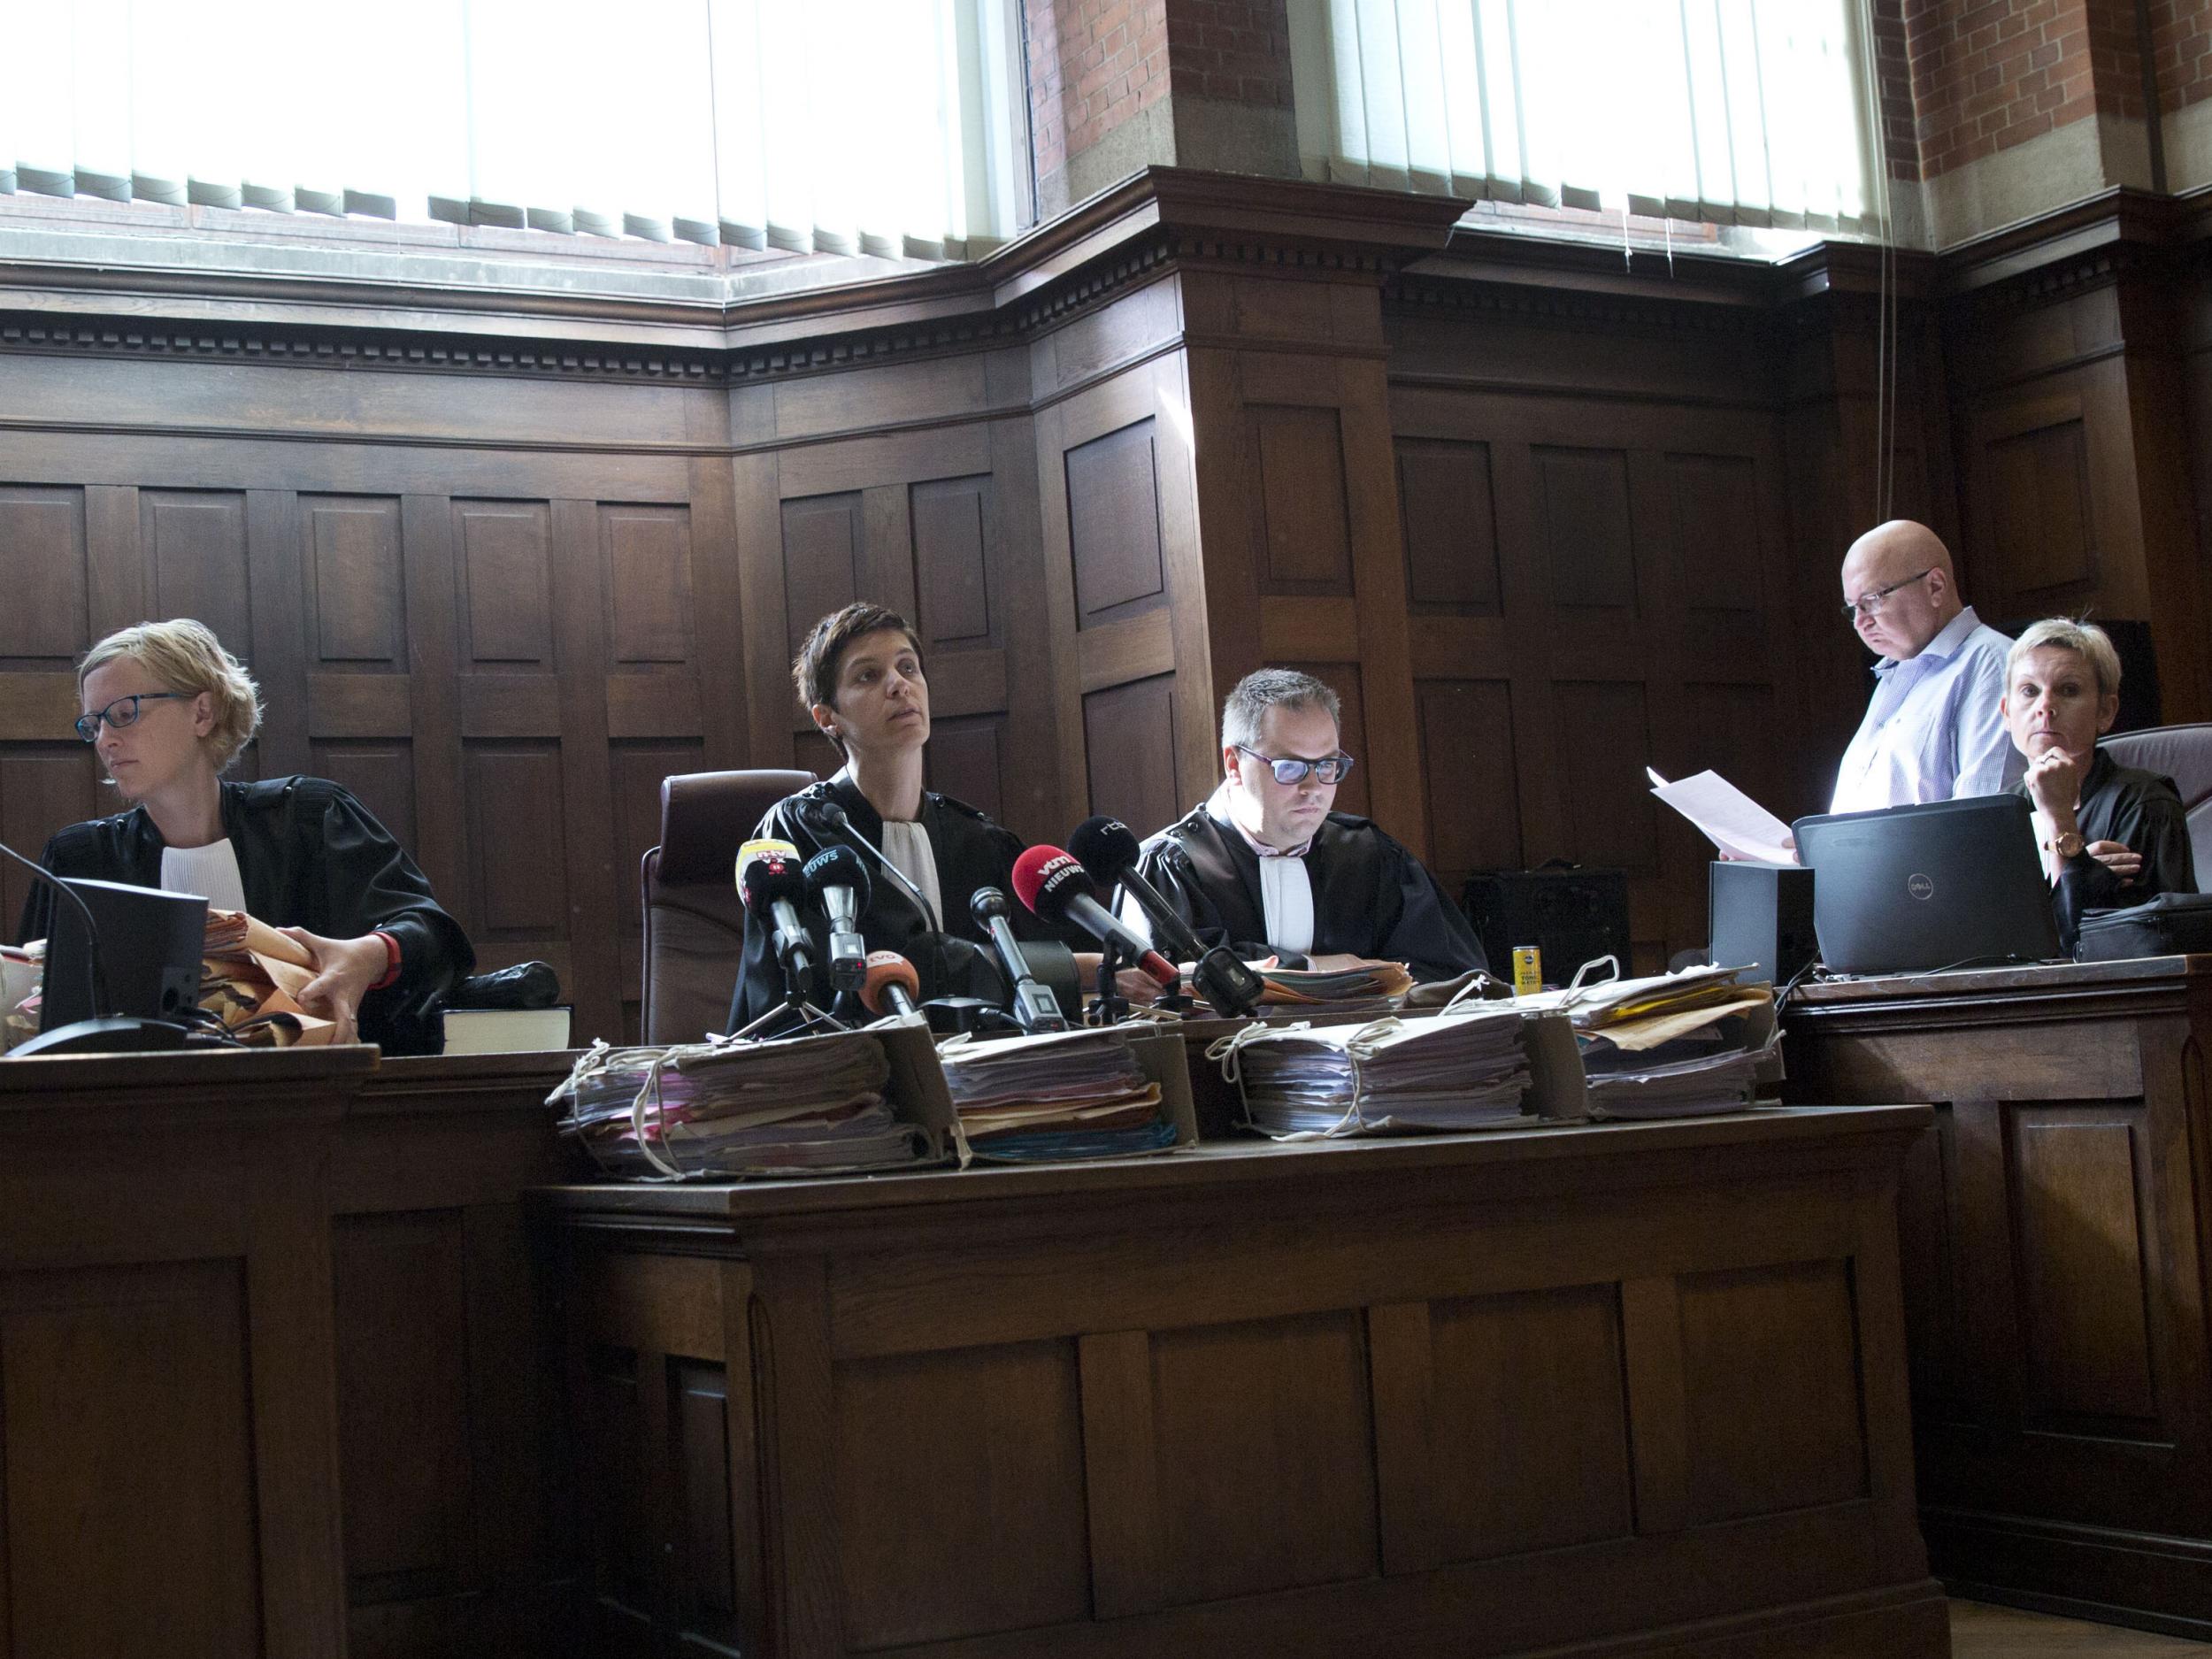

{"left": 938, "top": 1026, "right": 1175, "bottom": 1162}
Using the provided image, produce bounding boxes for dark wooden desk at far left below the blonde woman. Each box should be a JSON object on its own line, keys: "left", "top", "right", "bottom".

{"left": 0, "top": 1048, "right": 578, "bottom": 1659}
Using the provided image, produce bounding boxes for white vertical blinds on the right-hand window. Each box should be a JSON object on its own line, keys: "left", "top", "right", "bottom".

{"left": 1290, "top": 0, "right": 1878, "bottom": 230}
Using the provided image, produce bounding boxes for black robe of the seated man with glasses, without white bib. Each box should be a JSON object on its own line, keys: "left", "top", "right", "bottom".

{"left": 1140, "top": 805, "right": 1489, "bottom": 982}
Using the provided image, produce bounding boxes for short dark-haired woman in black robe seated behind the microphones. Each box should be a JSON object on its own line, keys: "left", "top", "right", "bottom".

{"left": 730, "top": 604, "right": 1095, "bottom": 1031}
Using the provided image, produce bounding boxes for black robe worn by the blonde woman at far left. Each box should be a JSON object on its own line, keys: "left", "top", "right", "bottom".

{"left": 20, "top": 777, "right": 476, "bottom": 1056}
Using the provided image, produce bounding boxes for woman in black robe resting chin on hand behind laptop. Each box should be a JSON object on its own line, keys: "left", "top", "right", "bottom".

{"left": 2002, "top": 618, "right": 2197, "bottom": 951}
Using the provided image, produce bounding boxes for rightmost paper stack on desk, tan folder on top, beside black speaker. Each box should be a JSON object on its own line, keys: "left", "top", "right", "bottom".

{"left": 1520, "top": 967, "right": 1777, "bottom": 1119}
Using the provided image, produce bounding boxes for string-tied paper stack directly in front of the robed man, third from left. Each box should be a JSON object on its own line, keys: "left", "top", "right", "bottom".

{"left": 1221, "top": 1004, "right": 1540, "bottom": 1140}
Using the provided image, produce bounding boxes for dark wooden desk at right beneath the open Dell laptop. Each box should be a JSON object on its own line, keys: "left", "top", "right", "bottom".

{"left": 1787, "top": 958, "right": 2212, "bottom": 1637}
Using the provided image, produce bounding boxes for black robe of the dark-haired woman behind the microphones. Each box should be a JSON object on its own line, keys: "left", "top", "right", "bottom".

{"left": 730, "top": 772, "right": 1097, "bottom": 1031}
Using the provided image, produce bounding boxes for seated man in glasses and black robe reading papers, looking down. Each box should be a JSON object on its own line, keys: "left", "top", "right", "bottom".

{"left": 1141, "top": 668, "right": 1486, "bottom": 980}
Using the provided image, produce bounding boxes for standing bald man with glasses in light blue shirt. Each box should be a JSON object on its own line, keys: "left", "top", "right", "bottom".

{"left": 1830, "top": 518, "right": 2022, "bottom": 812}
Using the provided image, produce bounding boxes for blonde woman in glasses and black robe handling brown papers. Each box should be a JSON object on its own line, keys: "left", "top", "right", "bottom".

{"left": 20, "top": 622, "right": 476, "bottom": 1053}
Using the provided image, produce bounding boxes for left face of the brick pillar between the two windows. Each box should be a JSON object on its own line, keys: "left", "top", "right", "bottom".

{"left": 1022, "top": 0, "right": 1168, "bottom": 188}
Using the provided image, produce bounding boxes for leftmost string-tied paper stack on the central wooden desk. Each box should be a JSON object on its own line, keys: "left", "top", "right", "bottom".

{"left": 547, "top": 1031, "right": 936, "bottom": 1177}
